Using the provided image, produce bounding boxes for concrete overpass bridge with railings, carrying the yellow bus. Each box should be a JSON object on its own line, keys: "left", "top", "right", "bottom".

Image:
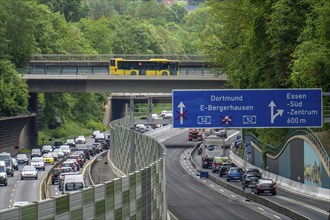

{"left": 23, "top": 54, "right": 228, "bottom": 93}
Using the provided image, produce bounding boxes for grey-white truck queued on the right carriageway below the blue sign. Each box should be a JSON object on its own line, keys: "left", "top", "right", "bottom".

{"left": 201, "top": 135, "right": 223, "bottom": 169}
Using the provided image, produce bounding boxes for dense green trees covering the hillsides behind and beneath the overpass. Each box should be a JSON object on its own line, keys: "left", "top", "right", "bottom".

{"left": 0, "top": 0, "right": 330, "bottom": 150}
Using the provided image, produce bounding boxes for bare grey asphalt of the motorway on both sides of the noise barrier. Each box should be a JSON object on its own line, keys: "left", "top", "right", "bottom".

{"left": 0, "top": 127, "right": 330, "bottom": 220}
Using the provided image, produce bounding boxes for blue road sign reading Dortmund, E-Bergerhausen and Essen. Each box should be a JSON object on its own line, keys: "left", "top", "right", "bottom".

{"left": 172, "top": 89, "right": 323, "bottom": 128}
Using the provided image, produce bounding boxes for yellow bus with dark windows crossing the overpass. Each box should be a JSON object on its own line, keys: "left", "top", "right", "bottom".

{"left": 109, "top": 58, "right": 179, "bottom": 76}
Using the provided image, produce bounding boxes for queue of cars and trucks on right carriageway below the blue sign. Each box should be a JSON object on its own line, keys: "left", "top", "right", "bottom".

{"left": 193, "top": 129, "right": 276, "bottom": 195}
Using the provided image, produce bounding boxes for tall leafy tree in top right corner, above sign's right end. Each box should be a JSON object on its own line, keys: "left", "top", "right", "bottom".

{"left": 291, "top": 0, "right": 330, "bottom": 92}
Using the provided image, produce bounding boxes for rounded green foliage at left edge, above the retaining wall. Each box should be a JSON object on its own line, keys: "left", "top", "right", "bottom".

{"left": 0, "top": 60, "right": 29, "bottom": 117}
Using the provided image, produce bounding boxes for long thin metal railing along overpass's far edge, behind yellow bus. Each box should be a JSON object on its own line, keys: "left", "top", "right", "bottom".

{"left": 30, "top": 54, "right": 206, "bottom": 62}
